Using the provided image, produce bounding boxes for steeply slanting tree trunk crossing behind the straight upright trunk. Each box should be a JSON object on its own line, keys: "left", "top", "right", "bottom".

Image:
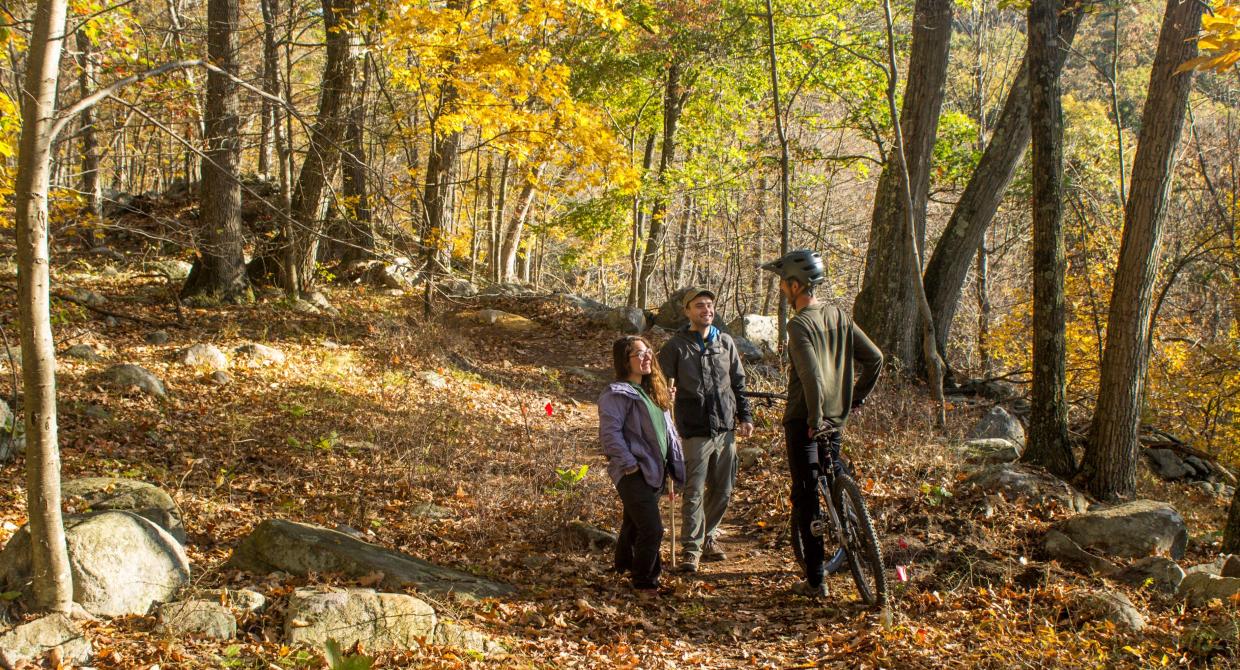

{"left": 925, "top": 10, "right": 1084, "bottom": 362}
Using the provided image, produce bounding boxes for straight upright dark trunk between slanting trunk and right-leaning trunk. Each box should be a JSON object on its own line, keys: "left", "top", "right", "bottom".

{"left": 1022, "top": 0, "right": 1076, "bottom": 478}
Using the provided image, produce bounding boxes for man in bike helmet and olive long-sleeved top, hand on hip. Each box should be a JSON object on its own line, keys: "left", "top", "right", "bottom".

{"left": 761, "top": 249, "right": 883, "bottom": 598}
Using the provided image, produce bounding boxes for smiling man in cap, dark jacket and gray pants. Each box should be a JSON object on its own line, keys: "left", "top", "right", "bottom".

{"left": 658, "top": 287, "right": 754, "bottom": 572}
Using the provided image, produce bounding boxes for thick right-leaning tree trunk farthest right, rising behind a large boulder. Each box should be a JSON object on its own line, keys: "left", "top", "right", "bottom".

{"left": 1081, "top": 0, "right": 1203, "bottom": 500}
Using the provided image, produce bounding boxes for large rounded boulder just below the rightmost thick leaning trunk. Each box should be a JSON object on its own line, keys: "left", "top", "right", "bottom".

{"left": 1059, "top": 500, "right": 1188, "bottom": 558}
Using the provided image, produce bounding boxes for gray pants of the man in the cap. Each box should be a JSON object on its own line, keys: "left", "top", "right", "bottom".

{"left": 681, "top": 431, "right": 737, "bottom": 556}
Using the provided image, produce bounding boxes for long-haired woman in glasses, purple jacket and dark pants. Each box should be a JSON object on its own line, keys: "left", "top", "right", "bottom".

{"left": 599, "top": 335, "right": 684, "bottom": 594}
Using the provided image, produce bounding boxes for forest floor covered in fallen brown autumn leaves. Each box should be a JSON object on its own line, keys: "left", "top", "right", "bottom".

{"left": 0, "top": 246, "right": 1238, "bottom": 669}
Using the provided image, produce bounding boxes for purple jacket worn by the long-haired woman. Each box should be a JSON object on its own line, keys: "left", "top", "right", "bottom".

{"left": 599, "top": 382, "right": 684, "bottom": 489}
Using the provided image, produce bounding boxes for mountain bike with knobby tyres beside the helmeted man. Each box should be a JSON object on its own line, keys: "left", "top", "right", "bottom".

{"left": 744, "top": 391, "right": 887, "bottom": 607}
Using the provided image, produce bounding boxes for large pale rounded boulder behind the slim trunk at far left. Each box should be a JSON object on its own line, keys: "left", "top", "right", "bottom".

{"left": 0, "top": 511, "right": 190, "bottom": 617}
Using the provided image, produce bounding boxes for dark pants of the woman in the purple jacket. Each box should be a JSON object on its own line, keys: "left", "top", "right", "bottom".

{"left": 615, "top": 471, "right": 663, "bottom": 588}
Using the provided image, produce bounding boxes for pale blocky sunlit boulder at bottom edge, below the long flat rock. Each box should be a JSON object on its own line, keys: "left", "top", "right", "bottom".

{"left": 284, "top": 587, "right": 439, "bottom": 649}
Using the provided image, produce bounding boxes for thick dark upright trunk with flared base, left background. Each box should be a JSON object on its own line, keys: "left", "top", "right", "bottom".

{"left": 181, "top": 0, "right": 250, "bottom": 302}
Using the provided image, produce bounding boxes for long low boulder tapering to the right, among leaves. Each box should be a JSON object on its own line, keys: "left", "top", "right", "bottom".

{"left": 228, "top": 520, "right": 512, "bottom": 598}
